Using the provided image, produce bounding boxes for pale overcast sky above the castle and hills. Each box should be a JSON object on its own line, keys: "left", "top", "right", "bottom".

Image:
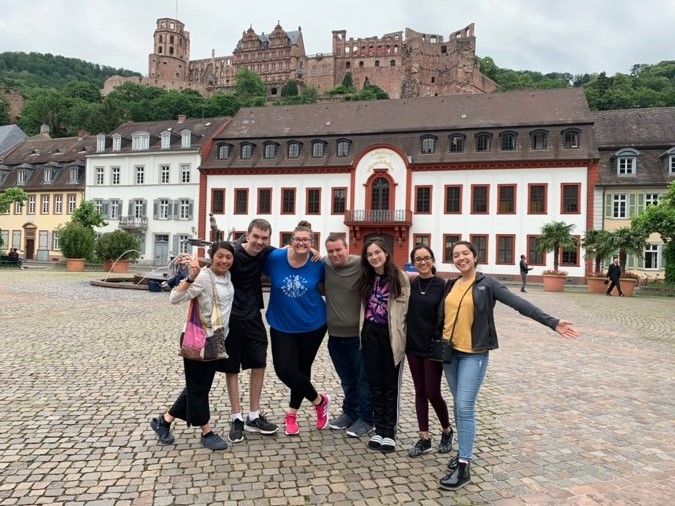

{"left": 0, "top": 0, "right": 675, "bottom": 75}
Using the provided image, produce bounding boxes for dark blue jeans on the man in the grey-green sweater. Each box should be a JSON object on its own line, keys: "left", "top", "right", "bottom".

{"left": 328, "top": 336, "right": 373, "bottom": 423}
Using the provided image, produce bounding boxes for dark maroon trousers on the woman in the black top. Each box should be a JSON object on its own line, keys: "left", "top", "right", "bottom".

{"left": 407, "top": 354, "right": 450, "bottom": 432}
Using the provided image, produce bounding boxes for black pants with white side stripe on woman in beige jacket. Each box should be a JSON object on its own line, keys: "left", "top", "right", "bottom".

{"left": 361, "top": 321, "right": 401, "bottom": 439}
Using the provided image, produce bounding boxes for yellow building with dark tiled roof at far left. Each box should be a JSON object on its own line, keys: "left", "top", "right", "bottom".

{"left": 0, "top": 133, "right": 96, "bottom": 262}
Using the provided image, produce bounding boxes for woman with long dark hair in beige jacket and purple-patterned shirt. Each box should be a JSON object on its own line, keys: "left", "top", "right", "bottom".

{"left": 359, "top": 237, "right": 410, "bottom": 453}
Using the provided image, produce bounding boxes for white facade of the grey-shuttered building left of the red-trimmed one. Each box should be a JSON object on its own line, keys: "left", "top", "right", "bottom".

{"left": 85, "top": 149, "right": 201, "bottom": 265}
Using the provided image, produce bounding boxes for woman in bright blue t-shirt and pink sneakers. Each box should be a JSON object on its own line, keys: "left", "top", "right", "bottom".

{"left": 264, "top": 221, "right": 330, "bottom": 436}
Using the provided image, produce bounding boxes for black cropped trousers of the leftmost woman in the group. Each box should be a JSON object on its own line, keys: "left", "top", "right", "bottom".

{"left": 169, "top": 358, "right": 218, "bottom": 426}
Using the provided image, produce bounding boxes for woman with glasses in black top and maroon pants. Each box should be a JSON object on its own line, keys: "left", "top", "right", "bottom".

{"left": 405, "top": 245, "right": 453, "bottom": 458}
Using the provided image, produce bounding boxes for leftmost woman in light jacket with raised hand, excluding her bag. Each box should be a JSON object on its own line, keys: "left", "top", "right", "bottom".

{"left": 150, "top": 242, "right": 234, "bottom": 450}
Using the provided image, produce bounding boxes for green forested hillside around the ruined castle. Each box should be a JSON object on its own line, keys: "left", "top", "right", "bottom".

{"left": 0, "top": 53, "right": 675, "bottom": 137}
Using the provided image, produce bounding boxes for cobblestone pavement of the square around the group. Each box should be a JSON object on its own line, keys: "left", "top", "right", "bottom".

{"left": 0, "top": 269, "right": 675, "bottom": 505}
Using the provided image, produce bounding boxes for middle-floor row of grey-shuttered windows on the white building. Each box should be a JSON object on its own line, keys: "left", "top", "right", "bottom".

{"left": 94, "top": 198, "right": 194, "bottom": 220}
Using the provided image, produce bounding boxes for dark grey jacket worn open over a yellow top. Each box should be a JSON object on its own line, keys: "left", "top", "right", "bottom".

{"left": 435, "top": 272, "right": 560, "bottom": 352}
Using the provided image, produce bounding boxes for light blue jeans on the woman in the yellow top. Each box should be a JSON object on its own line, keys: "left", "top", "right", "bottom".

{"left": 443, "top": 350, "right": 489, "bottom": 461}
